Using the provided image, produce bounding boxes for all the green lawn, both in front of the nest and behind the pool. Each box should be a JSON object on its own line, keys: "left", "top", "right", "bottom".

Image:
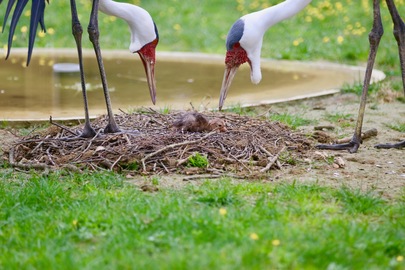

{"left": 0, "top": 0, "right": 405, "bottom": 269}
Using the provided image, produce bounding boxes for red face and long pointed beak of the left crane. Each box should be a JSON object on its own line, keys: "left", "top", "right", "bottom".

{"left": 137, "top": 37, "right": 159, "bottom": 104}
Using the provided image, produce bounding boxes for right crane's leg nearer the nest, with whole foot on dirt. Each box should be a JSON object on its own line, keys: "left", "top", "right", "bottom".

{"left": 316, "top": 0, "right": 384, "bottom": 153}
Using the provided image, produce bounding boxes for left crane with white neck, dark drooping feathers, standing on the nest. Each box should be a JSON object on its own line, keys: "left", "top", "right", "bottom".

{"left": 0, "top": 0, "right": 159, "bottom": 138}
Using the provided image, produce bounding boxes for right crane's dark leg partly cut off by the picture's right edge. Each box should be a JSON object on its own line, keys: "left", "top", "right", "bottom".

{"left": 375, "top": 0, "right": 405, "bottom": 149}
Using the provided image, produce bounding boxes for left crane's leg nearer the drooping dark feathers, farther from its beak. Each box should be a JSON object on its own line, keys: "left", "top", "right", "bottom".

{"left": 70, "top": 0, "right": 96, "bottom": 138}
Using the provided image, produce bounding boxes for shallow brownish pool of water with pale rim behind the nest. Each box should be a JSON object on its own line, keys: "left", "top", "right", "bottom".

{"left": 0, "top": 49, "right": 382, "bottom": 120}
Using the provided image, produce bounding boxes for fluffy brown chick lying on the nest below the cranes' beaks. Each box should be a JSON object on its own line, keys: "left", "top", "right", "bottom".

{"left": 173, "top": 112, "right": 227, "bottom": 132}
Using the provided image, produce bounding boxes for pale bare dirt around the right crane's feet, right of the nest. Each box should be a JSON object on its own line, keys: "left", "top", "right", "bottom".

{"left": 263, "top": 91, "right": 405, "bottom": 197}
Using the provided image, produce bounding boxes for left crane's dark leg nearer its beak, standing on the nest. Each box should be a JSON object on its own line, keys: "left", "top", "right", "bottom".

{"left": 87, "top": 0, "right": 120, "bottom": 133}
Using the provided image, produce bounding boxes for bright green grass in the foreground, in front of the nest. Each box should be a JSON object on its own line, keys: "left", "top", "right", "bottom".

{"left": 0, "top": 171, "right": 405, "bottom": 269}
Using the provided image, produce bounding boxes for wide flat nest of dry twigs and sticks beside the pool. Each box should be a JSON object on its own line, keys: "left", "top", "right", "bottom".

{"left": 9, "top": 109, "right": 311, "bottom": 177}
